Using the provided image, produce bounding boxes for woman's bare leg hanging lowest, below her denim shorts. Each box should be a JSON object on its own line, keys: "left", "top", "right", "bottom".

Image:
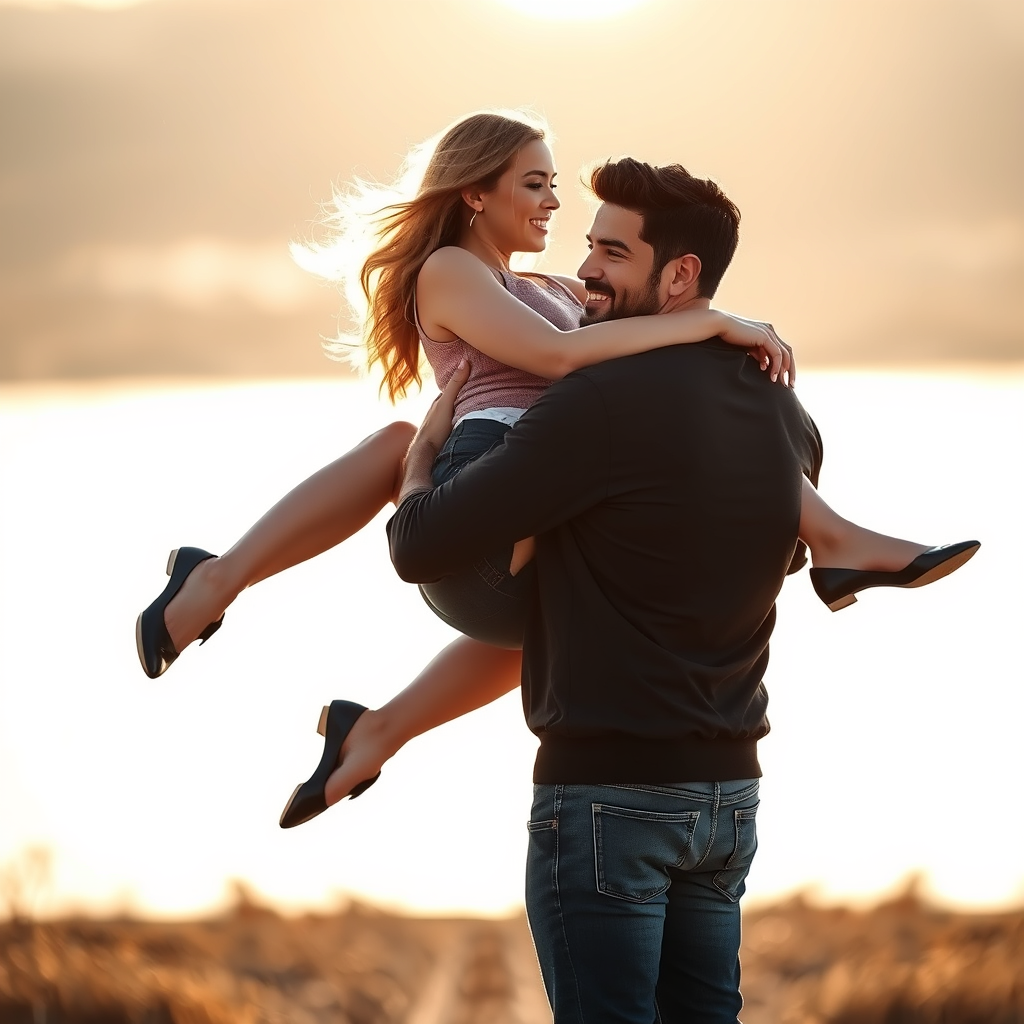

{"left": 326, "top": 637, "right": 522, "bottom": 805}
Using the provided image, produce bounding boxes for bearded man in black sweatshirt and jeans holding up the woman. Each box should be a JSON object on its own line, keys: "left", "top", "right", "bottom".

{"left": 388, "top": 160, "right": 820, "bottom": 1024}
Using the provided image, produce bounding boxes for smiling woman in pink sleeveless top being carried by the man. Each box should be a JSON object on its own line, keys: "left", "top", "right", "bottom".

{"left": 136, "top": 114, "right": 976, "bottom": 826}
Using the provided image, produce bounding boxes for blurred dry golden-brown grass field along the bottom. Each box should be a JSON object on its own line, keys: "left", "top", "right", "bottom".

{"left": 0, "top": 893, "right": 1024, "bottom": 1024}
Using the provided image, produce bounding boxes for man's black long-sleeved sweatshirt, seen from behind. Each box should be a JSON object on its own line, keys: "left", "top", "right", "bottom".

{"left": 388, "top": 339, "right": 821, "bottom": 783}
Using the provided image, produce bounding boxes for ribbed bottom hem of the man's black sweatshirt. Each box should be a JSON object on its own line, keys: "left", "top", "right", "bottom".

{"left": 534, "top": 735, "right": 761, "bottom": 785}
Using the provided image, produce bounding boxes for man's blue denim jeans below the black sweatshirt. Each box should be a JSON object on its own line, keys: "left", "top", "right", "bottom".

{"left": 526, "top": 779, "right": 758, "bottom": 1024}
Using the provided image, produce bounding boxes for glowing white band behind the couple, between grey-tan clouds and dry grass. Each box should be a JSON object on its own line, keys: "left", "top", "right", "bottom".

{"left": 0, "top": 373, "right": 1024, "bottom": 915}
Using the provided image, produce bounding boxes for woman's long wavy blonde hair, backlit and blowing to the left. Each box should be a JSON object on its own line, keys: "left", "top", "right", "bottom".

{"left": 292, "top": 111, "right": 547, "bottom": 401}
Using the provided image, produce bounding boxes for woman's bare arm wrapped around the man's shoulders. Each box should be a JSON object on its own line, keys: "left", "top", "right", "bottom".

{"left": 417, "top": 246, "right": 791, "bottom": 380}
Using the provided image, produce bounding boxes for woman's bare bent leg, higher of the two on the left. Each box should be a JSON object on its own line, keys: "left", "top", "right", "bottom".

{"left": 164, "top": 423, "right": 416, "bottom": 652}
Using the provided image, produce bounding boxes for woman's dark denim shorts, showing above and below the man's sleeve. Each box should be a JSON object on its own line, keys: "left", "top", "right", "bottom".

{"left": 420, "top": 420, "right": 537, "bottom": 649}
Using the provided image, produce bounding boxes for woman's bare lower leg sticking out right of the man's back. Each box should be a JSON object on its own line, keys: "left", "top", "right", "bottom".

{"left": 800, "top": 476, "right": 930, "bottom": 572}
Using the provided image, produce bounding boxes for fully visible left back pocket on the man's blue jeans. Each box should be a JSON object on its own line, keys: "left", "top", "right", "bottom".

{"left": 593, "top": 804, "right": 700, "bottom": 903}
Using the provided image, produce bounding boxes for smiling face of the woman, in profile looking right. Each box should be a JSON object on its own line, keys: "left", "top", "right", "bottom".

{"left": 474, "top": 139, "right": 561, "bottom": 253}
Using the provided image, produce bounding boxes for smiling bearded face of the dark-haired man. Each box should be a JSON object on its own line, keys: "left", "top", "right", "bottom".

{"left": 577, "top": 203, "right": 667, "bottom": 327}
